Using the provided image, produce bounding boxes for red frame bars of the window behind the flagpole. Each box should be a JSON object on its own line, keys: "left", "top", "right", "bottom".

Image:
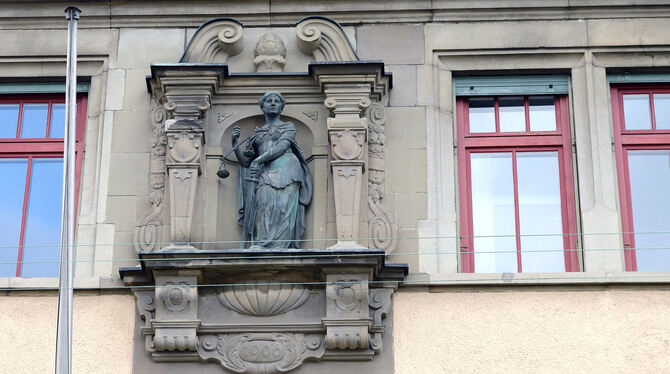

{"left": 0, "top": 94, "right": 87, "bottom": 277}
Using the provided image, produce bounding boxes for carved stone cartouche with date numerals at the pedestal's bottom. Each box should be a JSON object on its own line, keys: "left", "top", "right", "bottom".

{"left": 198, "top": 333, "right": 325, "bottom": 374}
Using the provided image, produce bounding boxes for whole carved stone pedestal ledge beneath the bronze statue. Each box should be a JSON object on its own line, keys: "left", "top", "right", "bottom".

{"left": 120, "top": 249, "right": 407, "bottom": 373}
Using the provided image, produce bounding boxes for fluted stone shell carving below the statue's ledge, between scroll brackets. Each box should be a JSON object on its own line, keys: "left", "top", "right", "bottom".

{"left": 218, "top": 282, "right": 310, "bottom": 317}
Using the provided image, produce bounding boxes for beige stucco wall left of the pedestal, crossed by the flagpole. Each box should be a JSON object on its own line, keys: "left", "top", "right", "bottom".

{"left": 0, "top": 295, "right": 135, "bottom": 374}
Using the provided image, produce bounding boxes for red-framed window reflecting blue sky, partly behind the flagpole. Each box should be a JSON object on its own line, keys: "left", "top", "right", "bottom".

{"left": 0, "top": 95, "right": 86, "bottom": 277}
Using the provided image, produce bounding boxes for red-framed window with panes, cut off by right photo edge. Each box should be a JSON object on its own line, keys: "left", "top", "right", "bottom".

{"left": 611, "top": 85, "right": 670, "bottom": 271}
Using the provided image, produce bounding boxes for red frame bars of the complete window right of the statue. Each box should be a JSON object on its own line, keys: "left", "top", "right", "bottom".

{"left": 456, "top": 95, "right": 580, "bottom": 273}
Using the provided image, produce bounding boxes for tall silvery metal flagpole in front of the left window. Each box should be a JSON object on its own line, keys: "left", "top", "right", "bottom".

{"left": 56, "top": 6, "right": 81, "bottom": 374}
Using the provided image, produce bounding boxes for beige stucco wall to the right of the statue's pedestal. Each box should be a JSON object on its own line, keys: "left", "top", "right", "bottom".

{"left": 393, "top": 287, "right": 670, "bottom": 374}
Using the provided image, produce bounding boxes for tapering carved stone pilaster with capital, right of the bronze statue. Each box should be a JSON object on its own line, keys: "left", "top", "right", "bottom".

{"left": 310, "top": 62, "right": 391, "bottom": 249}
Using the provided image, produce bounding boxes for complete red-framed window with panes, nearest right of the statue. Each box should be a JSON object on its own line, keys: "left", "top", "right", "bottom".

{"left": 456, "top": 86, "right": 580, "bottom": 273}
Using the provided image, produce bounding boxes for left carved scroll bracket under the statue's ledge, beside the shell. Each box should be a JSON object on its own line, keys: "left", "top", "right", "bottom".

{"left": 151, "top": 276, "right": 200, "bottom": 352}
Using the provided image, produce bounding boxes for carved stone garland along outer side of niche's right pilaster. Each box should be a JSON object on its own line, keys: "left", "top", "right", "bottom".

{"left": 368, "top": 103, "right": 396, "bottom": 251}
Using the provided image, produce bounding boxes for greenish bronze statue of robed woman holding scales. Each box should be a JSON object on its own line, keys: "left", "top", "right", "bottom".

{"left": 232, "top": 91, "right": 312, "bottom": 249}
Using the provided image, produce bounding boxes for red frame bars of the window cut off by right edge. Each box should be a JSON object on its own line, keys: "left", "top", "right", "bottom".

{"left": 610, "top": 84, "right": 670, "bottom": 271}
